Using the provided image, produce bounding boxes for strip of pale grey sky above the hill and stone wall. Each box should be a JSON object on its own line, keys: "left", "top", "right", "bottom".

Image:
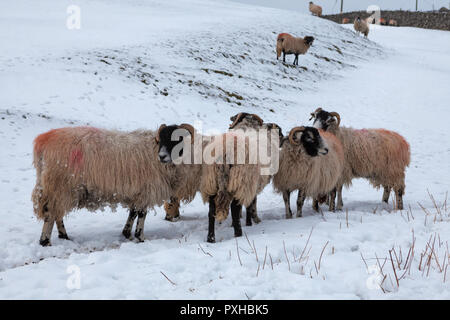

{"left": 233, "top": 0, "right": 450, "bottom": 14}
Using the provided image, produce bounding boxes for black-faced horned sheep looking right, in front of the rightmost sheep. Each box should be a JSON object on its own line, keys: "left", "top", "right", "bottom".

{"left": 273, "top": 127, "right": 344, "bottom": 219}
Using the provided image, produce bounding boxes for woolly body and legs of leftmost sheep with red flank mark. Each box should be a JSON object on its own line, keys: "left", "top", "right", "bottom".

{"left": 32, "top": 127, "right": 174, "bottom": 246}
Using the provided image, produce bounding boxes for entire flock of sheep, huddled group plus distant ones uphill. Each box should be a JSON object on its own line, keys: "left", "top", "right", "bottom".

{"left": 28, "top": 2, "right": 410, "bottom": 246}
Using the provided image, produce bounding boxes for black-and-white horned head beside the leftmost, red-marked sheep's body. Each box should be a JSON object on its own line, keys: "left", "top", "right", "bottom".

{"left": 155, "top": 124, "right": 194, "bottom": 163}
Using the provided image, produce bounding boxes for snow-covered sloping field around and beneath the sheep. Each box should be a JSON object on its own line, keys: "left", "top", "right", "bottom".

{"left": 0, "top": 0, "right": 450, "bottom": 299}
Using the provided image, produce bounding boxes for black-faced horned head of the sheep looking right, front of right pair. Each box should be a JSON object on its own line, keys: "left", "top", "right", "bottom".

{"left": 289, "top": 127, "right": 328, "bottom": 157}
